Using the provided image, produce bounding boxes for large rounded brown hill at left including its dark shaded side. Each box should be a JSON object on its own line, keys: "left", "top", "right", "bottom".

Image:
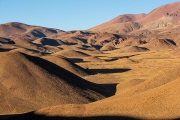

{"left": 0, "top": 52, "right": 112, "bottom": 114}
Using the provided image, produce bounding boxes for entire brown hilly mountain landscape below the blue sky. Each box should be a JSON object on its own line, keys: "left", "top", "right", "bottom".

{"left": 0, "top": 2, "right": 180, "bottom": 120}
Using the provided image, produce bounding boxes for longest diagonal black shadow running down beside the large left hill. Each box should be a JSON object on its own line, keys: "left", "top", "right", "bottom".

{"left": 21, "top": 53, "right": 117, "bottom": 97}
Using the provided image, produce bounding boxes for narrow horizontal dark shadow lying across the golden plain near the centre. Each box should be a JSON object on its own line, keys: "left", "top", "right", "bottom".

{"left": 89, "top": 68, "right": 131, "bottom": 74}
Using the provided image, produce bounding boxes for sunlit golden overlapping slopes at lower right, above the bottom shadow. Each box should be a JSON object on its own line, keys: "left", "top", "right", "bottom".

{"left": 18, "top": 66, "right": 180, "bottom": 119}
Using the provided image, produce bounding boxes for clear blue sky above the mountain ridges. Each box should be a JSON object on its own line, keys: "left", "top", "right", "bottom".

{"left": 0, "top": 0, "right": 178, "bottom": 31}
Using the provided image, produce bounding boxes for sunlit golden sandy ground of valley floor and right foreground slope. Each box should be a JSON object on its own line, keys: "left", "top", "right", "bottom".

{"left": 0, "top": 50, "right": 180, "bottom": 119}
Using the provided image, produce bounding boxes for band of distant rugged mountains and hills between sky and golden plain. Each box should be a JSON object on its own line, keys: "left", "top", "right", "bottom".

{"left": 0, "top": 2, "right": 180, "bottom": 54}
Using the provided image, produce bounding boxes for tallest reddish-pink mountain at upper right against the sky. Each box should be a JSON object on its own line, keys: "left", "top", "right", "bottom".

{"left": 89, "top": 2, "right": 180, "bottom": 34}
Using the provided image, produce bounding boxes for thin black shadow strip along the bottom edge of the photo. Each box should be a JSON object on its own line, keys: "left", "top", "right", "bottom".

{"left": 0, "top": 112, "right": 140, "bottom": 120}
